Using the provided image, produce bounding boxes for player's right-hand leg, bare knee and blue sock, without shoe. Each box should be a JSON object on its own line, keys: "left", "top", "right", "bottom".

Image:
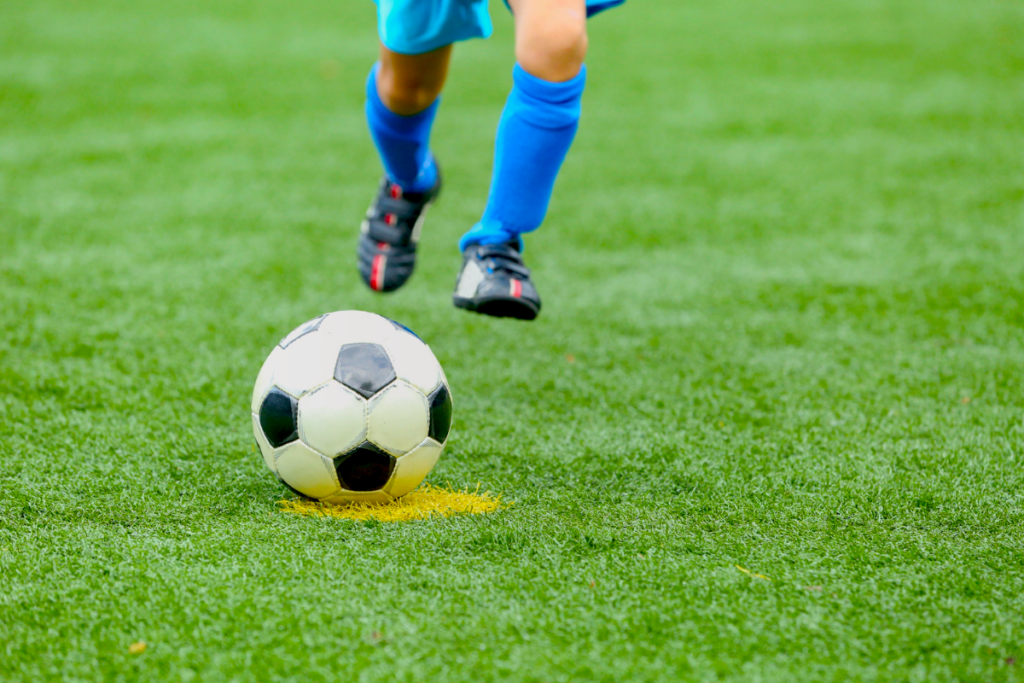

{"left": 460, "top": 0, "right": 587, "bottom": 251}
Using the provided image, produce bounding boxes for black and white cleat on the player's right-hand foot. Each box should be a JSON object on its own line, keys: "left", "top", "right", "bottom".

{"left": 452, "top": 242, "right": 541, "bottom": 321}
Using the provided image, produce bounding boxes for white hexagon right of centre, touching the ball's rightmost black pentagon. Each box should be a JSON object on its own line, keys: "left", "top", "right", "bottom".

{"left": 367, "top": 380, "right": 430, "bottom": 456}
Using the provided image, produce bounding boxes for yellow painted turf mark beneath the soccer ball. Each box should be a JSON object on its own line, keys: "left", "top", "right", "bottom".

{"left": 278, "top": 483, "right": 512, "bottom": 522}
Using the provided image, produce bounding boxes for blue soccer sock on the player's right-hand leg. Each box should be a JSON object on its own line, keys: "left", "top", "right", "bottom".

{"left": 459, "top": 65, "right": 587, "bottom": 251}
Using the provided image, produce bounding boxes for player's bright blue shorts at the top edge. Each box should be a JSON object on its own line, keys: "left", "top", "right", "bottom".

{"left": 374, "top": 0, "right": 626, "bottom": 54}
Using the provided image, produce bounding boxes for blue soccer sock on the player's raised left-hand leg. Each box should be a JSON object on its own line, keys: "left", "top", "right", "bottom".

{"left": 367, "top": 65, "right": 440, "bottom": 193}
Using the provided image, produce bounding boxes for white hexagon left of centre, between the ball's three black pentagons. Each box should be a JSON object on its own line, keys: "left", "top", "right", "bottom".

{"left": 299, "top": 380, "right": 367, "bottom": 458}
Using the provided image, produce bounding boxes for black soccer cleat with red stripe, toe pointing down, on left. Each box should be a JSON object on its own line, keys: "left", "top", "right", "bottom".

{"left": 356, "top": 169, "right": 441, "bottom": 292}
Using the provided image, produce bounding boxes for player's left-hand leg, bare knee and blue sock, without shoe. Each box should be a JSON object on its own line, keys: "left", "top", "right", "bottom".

{"left": 367, "top": 45, "right": 452, "bottom": 193}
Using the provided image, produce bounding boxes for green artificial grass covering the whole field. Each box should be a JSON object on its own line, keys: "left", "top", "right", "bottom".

{"left": 0, "top": 0, "right": 1024, "bottom": 683}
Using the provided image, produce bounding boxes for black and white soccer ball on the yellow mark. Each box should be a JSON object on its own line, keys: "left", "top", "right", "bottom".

{"left": 252, "top": 310, "right": 452, "bottom": 503}
